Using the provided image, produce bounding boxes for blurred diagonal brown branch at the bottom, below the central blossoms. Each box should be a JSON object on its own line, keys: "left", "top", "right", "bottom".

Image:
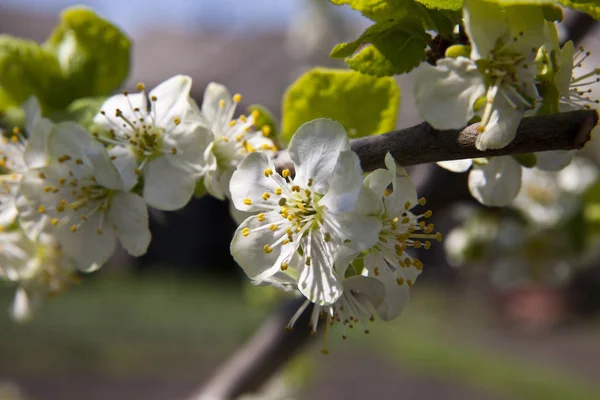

{"left": 190, "top": 298, "right": 311, "bottom": 400}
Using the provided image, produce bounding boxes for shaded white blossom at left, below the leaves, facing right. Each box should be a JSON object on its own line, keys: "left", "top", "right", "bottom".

{"left": 17, "top": 122, "right": 150, "bottom": 271}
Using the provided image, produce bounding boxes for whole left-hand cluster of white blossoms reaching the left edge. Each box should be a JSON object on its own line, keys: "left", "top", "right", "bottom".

{"left": 0, "top": 75, "right": 275, "bottom": 320}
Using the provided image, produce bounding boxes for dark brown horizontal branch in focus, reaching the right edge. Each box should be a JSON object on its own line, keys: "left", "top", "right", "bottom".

{"left": 275, "top": 110, "right": 598, "bottom": 171}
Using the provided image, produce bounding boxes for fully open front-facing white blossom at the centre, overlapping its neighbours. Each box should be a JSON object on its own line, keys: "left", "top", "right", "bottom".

{"left": 230, "top": 119, "right": 382, "bottom": 306}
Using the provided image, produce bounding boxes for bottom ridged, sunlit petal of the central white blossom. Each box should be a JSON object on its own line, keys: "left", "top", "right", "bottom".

{"left": 297, "top": 230, "right": 344, "bottom": 305}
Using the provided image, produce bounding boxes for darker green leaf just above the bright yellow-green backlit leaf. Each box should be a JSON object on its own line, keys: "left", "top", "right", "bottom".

{"left": 330, "top": 18, "right": 429, "bottom": 76}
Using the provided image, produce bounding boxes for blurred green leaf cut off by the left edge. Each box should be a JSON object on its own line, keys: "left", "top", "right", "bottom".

{"left": 0, "top": 35, "right": 63, "bottom": 111}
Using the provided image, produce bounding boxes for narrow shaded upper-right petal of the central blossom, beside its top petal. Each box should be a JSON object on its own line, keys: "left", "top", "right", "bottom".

{"left": 319, "top": 150, "right": 362, "bottom": 212}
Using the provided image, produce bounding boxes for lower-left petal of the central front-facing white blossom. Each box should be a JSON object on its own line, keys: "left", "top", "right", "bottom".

{"left": 230, "top": 214, "right": 294, "bottom": 281}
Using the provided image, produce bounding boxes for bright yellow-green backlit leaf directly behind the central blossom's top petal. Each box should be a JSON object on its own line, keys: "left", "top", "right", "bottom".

{"left": 282, "top": 68, "right": 400, "bottom": 142}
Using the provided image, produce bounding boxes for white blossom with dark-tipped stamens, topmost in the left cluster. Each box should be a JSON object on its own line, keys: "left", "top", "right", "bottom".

{"left": 94, "top": 75, "right": 211, "bottom": 210}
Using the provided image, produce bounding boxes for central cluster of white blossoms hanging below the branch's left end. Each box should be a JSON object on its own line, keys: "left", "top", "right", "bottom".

{"left": 230, "top": 119, "right": 441, "bottom": 350}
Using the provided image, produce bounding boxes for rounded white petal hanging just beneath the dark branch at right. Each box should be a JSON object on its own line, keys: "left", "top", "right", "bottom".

{"left": 469, "top": 156, "right": 521, "bottom": 207}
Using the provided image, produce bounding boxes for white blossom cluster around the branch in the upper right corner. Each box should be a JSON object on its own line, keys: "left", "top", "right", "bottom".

{"left": 415, "top": 0, "right": 600, "bottom": 206}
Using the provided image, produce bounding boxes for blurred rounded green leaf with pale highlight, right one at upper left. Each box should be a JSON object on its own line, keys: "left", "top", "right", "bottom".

{"left": 44, "top": 6, "right": 131, "bottom": 100}
